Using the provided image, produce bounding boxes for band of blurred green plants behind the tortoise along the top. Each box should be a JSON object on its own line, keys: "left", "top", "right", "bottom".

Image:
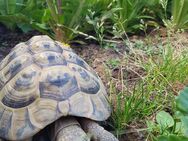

{"left": 0, "top": 0, "right": 188, "bottom": 43}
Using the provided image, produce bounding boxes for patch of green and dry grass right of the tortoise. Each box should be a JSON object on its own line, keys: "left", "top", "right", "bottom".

{"left": 107, "top": 34, "right": 188, "bottom": 138}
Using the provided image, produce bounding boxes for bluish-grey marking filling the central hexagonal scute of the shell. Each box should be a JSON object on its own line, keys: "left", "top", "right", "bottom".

{"left": 39, "top": 73, "right": 79, "bottom": 101}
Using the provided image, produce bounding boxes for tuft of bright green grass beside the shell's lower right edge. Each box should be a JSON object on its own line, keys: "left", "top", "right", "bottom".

{"left": 110, "top": 79, "right": 158, "bottom": 137}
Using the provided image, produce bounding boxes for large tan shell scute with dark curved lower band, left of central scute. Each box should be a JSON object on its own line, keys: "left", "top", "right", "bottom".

{"left": 0, "top": 65, "right": 40, "bottom": 108}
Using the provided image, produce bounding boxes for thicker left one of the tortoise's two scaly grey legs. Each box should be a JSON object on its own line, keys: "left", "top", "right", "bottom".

{"left": 52, "top": 117, "right": 90, "bottom": 141}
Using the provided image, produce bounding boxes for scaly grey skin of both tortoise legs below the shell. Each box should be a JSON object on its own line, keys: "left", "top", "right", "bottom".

{"left": 51, "top": 117, "right": 118, "bottom": 141}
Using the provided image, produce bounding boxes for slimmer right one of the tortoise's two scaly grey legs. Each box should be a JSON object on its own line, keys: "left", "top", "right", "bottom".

{"left": 80, "top": 118, "right": 118, "bottom": 141}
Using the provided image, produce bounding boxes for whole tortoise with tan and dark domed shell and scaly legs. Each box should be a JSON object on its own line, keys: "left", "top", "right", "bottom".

{"left": 0, "top": 35, "right": 117, "bottom": 141}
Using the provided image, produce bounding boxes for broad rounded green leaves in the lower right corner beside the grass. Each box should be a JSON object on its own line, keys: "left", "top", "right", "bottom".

{"left": 147, "top": 87, "right": 188, "bottom": 141}
